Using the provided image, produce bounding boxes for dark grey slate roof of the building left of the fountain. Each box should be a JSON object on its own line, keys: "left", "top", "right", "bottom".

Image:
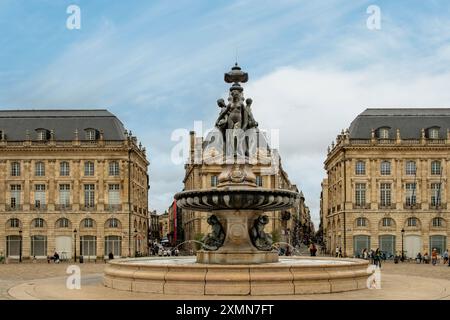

{"left": 0, "top": 109, "right": 125, "bottom": 141}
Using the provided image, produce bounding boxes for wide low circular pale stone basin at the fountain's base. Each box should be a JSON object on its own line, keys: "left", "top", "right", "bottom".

{"left": 104, "top": 257, "right": 371, "bottom": 296}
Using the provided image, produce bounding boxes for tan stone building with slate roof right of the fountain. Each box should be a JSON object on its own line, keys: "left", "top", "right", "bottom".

{"left": 321, "top": 109, "right": 450, "bottom": 257}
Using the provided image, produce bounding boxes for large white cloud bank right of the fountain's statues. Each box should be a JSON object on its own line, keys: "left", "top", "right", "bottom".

{"left": 245, "top": 66, "right": 450, "bottom": 226}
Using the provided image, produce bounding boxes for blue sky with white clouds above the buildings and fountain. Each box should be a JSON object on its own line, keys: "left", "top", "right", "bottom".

{"left": 0, "top": 0, "right": 450, "bottom": 225}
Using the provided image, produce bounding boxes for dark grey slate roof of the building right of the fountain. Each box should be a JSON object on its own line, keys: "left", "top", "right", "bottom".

{"left": 349, "top": 108, "right": 450, "bottom": 139}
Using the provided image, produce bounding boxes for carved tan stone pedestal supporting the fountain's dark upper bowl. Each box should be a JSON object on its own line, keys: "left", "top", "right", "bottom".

{"left": 197, "top": 210, "right": 278, "bottom": 264}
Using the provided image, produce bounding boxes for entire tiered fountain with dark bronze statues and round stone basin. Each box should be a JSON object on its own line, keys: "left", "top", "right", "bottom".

{"left": 104, "top": 64, "right": 369, "bottom": 295}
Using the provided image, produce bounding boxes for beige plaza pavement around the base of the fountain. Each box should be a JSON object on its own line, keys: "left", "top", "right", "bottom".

{"left": 0, "top": 262, "right": 450, "bottom": 300}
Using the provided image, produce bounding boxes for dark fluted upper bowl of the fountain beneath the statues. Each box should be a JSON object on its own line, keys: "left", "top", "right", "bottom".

{"left": 175, "top": 187, "right": 299, "bottom": 212}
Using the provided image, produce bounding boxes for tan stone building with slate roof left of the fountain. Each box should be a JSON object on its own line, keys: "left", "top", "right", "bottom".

{"left": 0, "top": 110, "right": 149, "bottom": 259}
